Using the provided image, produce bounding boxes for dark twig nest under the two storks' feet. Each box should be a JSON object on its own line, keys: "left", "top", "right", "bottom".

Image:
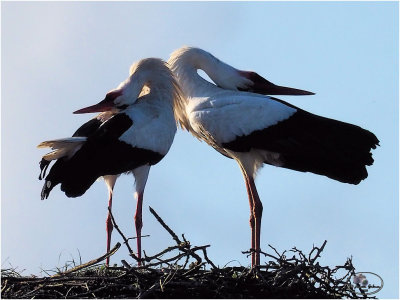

{"left": 1, "top": 208, "right": 378, "bottom": 299}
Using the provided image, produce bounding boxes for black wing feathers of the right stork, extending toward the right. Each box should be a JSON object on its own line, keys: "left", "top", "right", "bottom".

{"left": 223, "top": 98, "right": 379, "bottom": 184}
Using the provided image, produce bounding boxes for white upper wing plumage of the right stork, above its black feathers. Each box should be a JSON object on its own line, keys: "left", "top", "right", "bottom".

{"left": 186, "top": 90, "right": 296, "bottom": 147}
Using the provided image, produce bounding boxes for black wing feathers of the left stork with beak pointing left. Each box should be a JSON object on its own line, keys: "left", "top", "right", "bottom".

{"left": 42, "top": 113, "right": 163, "bottom": 199}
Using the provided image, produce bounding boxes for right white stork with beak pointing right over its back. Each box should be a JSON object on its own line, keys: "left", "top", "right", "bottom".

{"left": 168, "top": 47, "right": 379, "bottom": 266}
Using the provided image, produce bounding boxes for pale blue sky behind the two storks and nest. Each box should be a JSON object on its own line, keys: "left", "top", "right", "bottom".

{"left": 1, "top": 2, "right": 399, "bottom": 298}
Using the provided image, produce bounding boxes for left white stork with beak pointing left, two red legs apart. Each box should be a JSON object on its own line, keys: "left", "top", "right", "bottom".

{"left": 38, "top": 58, "right": 183, "bottom": 265}
